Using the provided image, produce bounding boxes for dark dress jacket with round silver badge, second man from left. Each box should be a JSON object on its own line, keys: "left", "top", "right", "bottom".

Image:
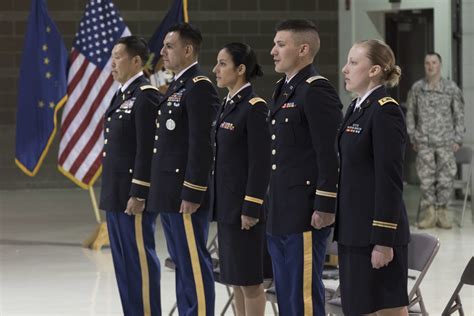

{"left": 147, "top": 65, "right": 219, "bottom": 213}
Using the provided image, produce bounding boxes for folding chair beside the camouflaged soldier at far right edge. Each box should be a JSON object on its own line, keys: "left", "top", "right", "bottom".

{"left": 453, "top": 146, "right": 474, "bottom": 227}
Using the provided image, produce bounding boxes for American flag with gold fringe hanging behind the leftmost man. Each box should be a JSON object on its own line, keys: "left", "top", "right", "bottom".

{"left": 58, "top": 0, "right": 131, "bottom": 189}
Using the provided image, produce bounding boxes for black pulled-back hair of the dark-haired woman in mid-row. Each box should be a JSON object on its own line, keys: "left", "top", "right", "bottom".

{"left": 223, "top": 42, "right": 263, "bottom": 81}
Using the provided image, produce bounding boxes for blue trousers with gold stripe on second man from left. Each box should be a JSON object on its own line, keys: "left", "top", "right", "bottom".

{"left": 160, "top": 211, "right": 215, "bottom": 316}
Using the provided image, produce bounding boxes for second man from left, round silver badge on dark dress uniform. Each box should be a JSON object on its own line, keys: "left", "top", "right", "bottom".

{"left": 147, "top": 23, "right": 219, "bottom": 316}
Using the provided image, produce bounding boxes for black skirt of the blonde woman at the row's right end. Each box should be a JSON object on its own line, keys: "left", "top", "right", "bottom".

{"left": 338, "top": 244, "right": 408, "bottom": 315}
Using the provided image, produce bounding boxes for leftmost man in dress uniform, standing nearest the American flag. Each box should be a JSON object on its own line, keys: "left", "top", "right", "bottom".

{"left": 100, "top": 36, "right": 161, "bottom": 315}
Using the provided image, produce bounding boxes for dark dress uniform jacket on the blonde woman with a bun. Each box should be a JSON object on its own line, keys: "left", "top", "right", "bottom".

{"left": 334, "top": 86, "right": 409, "bottom": 247}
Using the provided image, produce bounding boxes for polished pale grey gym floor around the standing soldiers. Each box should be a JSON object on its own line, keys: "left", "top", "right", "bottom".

{"left": 0, "top": 186, "right": 474, "bottom": 316}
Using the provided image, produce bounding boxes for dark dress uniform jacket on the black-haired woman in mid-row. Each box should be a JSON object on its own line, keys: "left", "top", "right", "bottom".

{"left": 211, "top": 86, "right": 270, "bottom": 224}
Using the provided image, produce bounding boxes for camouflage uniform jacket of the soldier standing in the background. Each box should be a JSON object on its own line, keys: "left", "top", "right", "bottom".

{"left": 406, "top": 78, "right": 464, "bottom": 145}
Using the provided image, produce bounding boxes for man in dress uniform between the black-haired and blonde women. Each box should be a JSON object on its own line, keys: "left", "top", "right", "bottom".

{"left": 267, "top": 20, "right": 342, "bottom": 316}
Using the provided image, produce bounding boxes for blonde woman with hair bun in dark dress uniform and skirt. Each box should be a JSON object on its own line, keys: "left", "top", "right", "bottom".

{"left": 335, "top": 40, "right": 410, "bottom": 315}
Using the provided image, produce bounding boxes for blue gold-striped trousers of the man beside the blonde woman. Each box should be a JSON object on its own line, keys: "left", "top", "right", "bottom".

{"left": 267, "top": 228, "right": 330, "bottom": 316}
